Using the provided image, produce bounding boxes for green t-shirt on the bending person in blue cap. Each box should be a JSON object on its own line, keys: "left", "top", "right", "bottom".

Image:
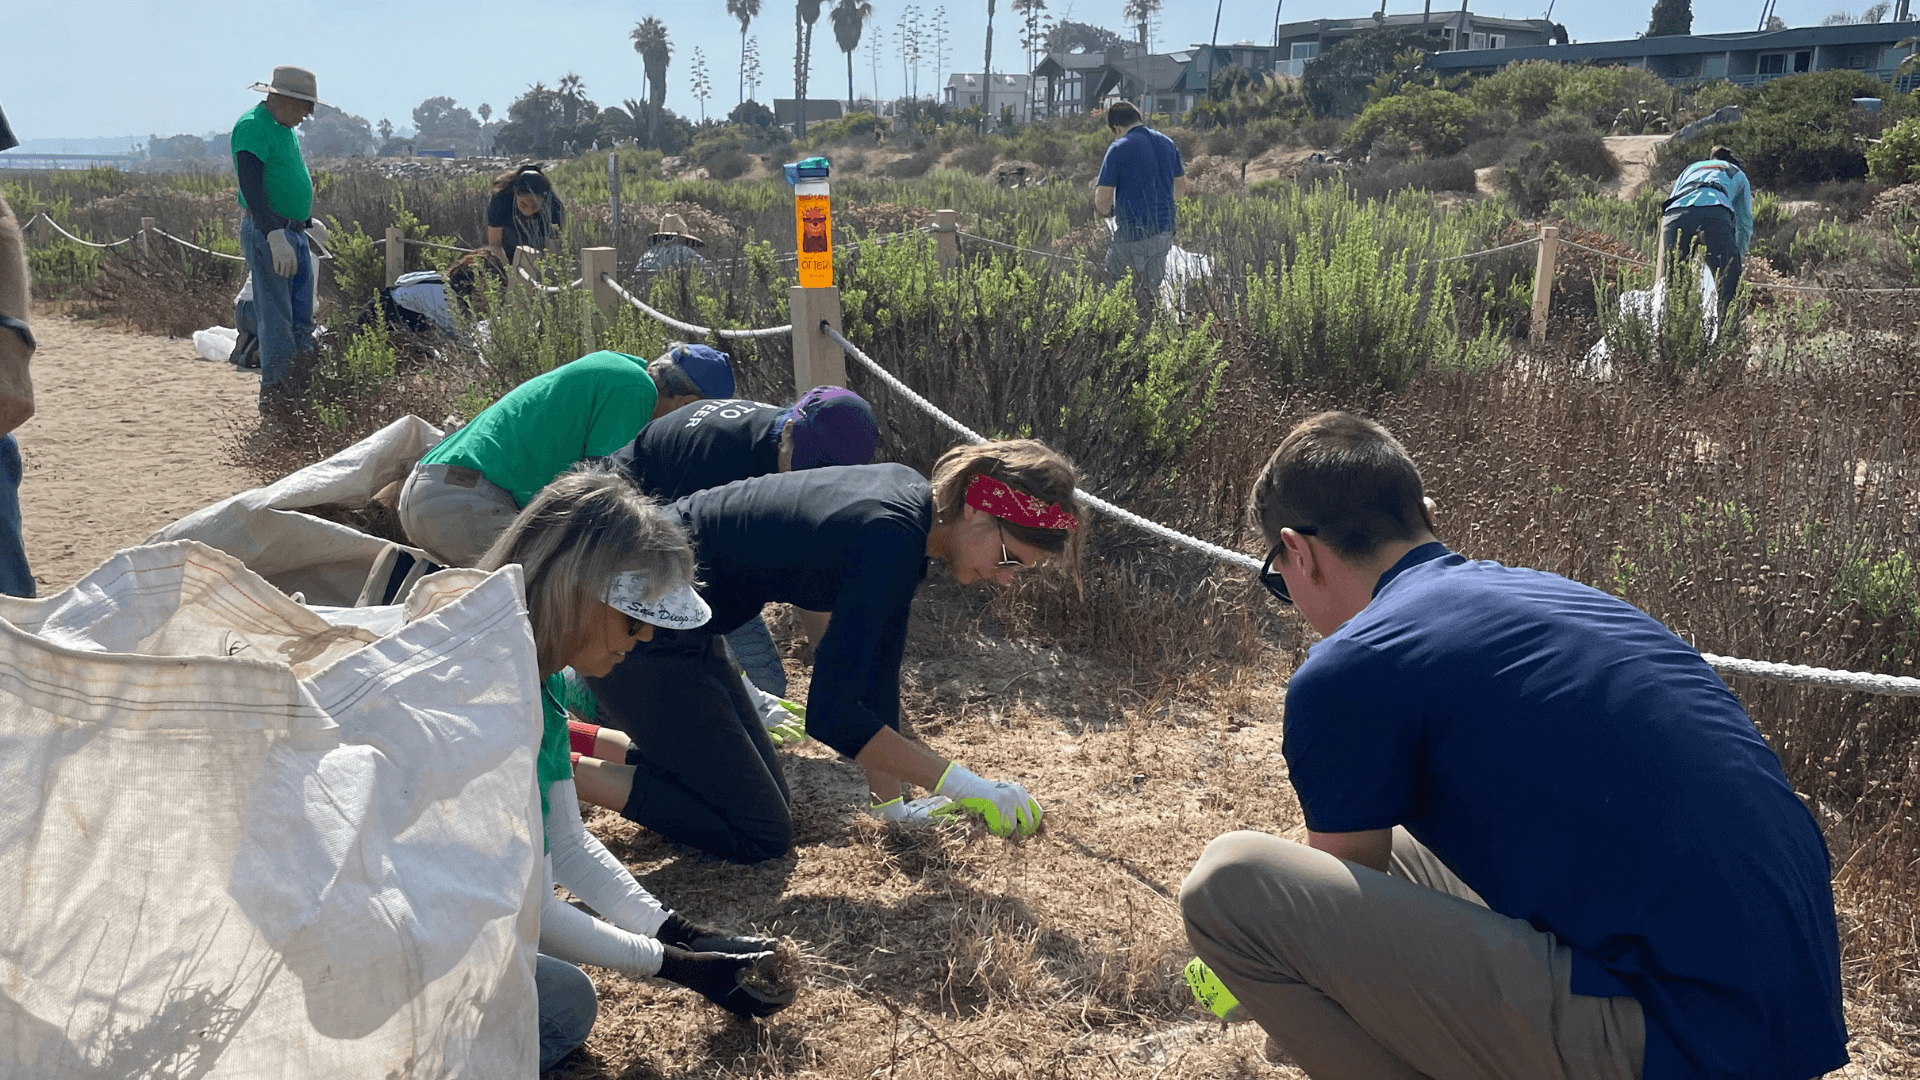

{"left": 420, "top": 352, "right": 659, "bottom": 507}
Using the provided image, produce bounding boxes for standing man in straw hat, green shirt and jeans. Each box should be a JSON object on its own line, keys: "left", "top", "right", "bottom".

{"left": 230, "top": 65, "right": 326, "bottom": 423}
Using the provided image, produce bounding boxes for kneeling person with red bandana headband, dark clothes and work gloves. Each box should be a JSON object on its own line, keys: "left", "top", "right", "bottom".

{"left": 576, "top": 440, "right": 1085, "bottom": 863}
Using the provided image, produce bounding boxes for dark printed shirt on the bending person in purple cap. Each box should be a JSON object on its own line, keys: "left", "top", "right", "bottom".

{"left": 611, "top": 398, "right": 787, "bottom": 502}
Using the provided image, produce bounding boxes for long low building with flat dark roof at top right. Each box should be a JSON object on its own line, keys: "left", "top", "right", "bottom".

{"left": 1427, "top": 19, "right": 1920, "bottom": 92}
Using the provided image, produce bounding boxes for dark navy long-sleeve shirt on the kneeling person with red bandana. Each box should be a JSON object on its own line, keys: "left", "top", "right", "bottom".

{"left": 670, "top": 463, "right": 933, "bottom": 757}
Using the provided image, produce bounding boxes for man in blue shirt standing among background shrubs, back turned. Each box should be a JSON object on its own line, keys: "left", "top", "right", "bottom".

{"left": 1092, "top": 102, "right": 1187, "bottom": 292}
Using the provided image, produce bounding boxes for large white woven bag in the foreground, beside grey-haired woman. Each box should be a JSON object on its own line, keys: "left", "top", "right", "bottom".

{"left": 0, "top": 542, "right": 541, "bottom": 1080}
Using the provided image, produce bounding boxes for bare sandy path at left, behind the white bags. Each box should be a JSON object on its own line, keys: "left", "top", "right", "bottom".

{"left": 15, "top": 311, "right": 259, "bottom": 596}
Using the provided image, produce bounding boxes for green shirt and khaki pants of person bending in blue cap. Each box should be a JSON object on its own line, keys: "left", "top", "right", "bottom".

{"left": 399, "top": 352, "right": 657, "bottom": 567}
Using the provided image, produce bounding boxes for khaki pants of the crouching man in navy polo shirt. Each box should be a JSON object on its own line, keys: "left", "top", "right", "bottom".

{"left": 1181, "top": 828, "right": 1645, "bottom": 1080}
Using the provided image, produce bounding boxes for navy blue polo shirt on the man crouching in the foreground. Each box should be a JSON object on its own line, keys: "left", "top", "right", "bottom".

{"left": 1283, "top": 544, "right": 1847, "bottom": 1080}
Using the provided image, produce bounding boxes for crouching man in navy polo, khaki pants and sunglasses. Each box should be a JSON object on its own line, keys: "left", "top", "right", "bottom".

{"left": 1181, "top": 413, "right": 1847, "bottom": 1080}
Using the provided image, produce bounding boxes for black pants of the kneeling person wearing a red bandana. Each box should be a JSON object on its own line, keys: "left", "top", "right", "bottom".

{"left": 588, "top": 630, "right": 793, "bottom": 863}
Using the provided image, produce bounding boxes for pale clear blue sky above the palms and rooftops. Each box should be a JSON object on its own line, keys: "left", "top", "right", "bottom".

{"left": 0, "top": 0, "right": 1870, "bottom": 140}
